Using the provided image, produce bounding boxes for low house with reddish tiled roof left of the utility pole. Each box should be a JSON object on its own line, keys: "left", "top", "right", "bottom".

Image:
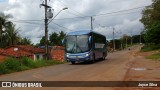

{"left": 2, "top": 45, "right": 45, "bottom": 60}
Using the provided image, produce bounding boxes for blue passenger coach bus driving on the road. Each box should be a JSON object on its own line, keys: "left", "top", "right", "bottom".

{"left": 62, "top": 30, "right": 107, "bottom": 64}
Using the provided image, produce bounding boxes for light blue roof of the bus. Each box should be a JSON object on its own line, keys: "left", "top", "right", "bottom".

{"left": 67, "top": 30, "right": 104, "bottom": 36}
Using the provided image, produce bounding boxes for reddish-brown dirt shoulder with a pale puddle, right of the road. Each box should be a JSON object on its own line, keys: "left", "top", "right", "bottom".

{"left": 121, "top": 47, "right": 160, "bottom": 90}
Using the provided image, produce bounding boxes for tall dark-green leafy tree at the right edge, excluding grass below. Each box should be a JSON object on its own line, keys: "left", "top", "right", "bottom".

{"left": 140, "top": 0, "right": 160, "bottom": 44}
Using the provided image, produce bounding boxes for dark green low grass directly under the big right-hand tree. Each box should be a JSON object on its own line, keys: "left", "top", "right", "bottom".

{"left": 141, "top": 44, "right": 160, "bottom": 52}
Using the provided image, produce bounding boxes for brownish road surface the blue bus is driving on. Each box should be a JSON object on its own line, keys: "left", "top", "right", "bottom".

{"left": 0, "top": 46, "right": 140, "bottom": 90}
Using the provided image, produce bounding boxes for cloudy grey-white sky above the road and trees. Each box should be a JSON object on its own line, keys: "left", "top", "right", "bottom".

{"left": 0, "top": 0, "right": 152, "bottom": 44}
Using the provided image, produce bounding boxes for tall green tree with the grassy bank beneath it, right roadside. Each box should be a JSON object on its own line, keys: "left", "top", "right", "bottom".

{"left": 140, "top": 0, "right": 160, "bottom": 60}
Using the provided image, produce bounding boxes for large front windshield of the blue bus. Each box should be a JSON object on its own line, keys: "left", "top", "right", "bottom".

{"left": 66, "top": 35, "right": 89, "bottom": 53}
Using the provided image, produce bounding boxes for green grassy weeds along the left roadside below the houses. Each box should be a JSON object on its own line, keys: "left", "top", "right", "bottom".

{"left": 0, "top": 57, "right": 64, "bottom": 75}
